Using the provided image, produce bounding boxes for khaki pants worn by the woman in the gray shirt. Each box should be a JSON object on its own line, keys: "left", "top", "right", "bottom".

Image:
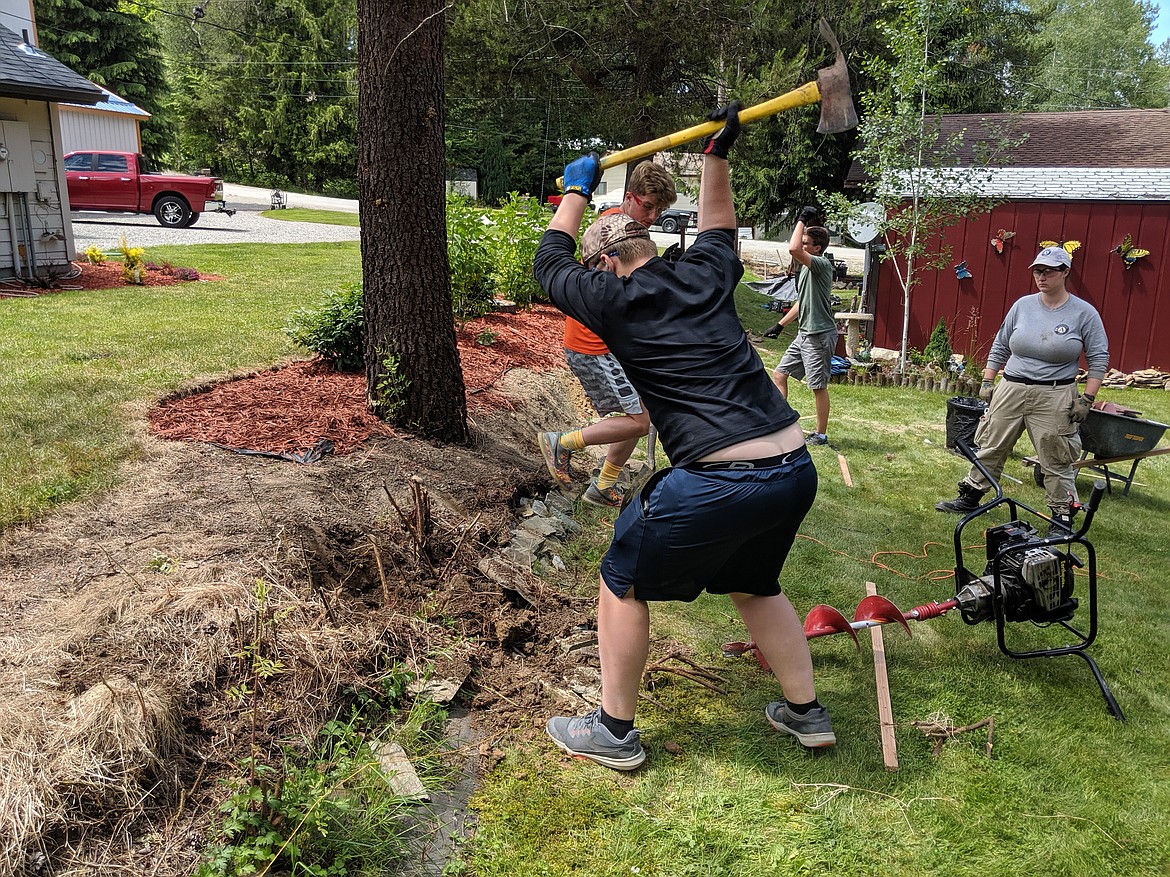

{"left": 963, "top": 380, "right": 1081, "bottom": 515}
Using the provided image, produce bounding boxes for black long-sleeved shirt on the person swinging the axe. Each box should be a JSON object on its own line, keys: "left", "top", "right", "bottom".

{"left": 535, "top": 229, "right": 798, "bottom": 465}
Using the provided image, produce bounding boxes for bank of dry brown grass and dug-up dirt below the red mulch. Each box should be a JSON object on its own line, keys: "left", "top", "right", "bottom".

{"left": 0, "top": 373, "right": 579, "bottom": 877}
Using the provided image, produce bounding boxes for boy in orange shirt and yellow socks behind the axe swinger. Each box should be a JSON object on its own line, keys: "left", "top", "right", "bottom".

{"left": 537, "top": 161, "right": 679, "bottom": 507}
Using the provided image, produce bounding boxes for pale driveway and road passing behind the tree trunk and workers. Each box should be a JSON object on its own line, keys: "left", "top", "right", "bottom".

{"left": 73, "top": 188, "right": 863, "bottom": 274}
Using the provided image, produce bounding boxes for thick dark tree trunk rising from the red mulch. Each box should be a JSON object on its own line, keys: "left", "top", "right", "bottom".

{"left": 358, "top": 0, "right": 469, "bottom": 442}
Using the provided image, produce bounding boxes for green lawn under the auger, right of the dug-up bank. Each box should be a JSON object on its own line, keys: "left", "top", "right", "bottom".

{"left": 469, "top": 288, "right": 1170, "bottom": 877}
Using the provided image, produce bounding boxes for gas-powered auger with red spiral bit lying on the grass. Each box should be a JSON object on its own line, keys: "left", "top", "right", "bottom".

{"left": 723, "top": 440, "right": 1126, "bottom": 721}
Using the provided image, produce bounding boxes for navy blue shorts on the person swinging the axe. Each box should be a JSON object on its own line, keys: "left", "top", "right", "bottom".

{"left": 601, "top": 448, "right": 817, "bottom": 601}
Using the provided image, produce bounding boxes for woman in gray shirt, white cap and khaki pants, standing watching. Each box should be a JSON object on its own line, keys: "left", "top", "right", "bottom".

{"left": 935, "top": 247, "right": 1109, "bottom": 534}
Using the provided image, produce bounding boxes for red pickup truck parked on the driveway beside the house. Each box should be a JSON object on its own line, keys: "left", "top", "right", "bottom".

{"left": 66, "top": 150, "right": 235, "bottom": 228}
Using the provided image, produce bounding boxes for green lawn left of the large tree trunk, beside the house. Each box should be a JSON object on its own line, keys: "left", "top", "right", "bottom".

{"left": 0, "top": 243, "right": 362, "bottom": 529}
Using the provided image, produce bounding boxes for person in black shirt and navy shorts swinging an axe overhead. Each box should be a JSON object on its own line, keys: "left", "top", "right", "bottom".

{"left": 535, "top": 103, "right": 837, "bottom": 771}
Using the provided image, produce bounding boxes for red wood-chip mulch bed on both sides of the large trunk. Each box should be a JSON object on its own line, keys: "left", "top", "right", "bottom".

{"left": 150, "top": 305, "right": 565, "bottom": 457}
